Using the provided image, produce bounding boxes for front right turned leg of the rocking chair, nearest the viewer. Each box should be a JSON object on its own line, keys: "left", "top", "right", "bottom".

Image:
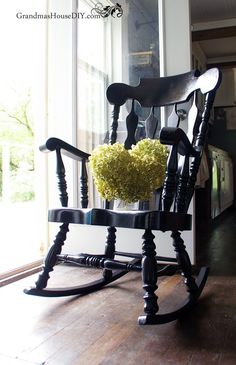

{"left": 139, "top": 229, "right": 159, "bottom": 324}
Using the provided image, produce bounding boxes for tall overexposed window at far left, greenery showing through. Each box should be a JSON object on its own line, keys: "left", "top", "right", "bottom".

{"left": 0, "top": 0, "right": 46, "bottom": 278}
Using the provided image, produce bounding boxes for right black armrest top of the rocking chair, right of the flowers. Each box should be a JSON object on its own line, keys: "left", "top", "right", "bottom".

{"left": 160, "top": 127, "right": 199, "bottom": 157}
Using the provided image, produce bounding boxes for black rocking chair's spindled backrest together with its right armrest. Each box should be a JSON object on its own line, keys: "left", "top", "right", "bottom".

{"left": 107, "top": 68, "right": 221, "bottom": 213}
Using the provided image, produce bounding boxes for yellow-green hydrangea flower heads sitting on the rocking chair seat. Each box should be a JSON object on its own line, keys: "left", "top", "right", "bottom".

{"left": 89, "top": 138, "right": 168, "bottom": 203}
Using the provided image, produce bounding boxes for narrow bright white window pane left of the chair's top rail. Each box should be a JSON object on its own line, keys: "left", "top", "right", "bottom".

{"left": 78, "top": 0, "right": 108, "bottom": 152}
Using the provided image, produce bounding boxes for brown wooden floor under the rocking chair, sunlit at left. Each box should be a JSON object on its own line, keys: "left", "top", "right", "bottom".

{"left": 0, "top": 208, "right": 236, "bottom": 365}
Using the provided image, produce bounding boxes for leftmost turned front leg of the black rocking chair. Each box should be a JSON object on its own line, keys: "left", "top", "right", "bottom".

{"left": 35, "top": 223, "right": 69, "bottom": 289}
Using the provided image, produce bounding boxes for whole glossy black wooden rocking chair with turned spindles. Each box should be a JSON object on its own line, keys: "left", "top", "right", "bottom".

{"left": 25, "top": 68, "right": 221, "bottom": 324}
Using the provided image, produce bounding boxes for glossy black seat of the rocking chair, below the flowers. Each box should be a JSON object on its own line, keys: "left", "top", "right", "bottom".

{"left": 48, "top": 208, "right": 192, "bottom": 232}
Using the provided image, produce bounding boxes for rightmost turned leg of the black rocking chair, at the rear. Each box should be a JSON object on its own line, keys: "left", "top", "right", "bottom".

{"left": 171, "top": 231, "right": 198, "bottom": 294}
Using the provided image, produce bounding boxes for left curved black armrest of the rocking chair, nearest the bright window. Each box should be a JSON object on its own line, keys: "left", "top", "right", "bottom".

{"left": 39, "top": 137, "right": 90, "bottom": 161}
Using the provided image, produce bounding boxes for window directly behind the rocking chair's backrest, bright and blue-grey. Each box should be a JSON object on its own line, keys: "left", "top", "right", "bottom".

{"left": 77, "top": 0, "right": 159, "bottom": 208}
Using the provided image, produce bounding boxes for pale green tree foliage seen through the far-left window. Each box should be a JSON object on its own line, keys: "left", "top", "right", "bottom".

{"left": 0, "top": 96, "right": 35, "bottom": 202}
